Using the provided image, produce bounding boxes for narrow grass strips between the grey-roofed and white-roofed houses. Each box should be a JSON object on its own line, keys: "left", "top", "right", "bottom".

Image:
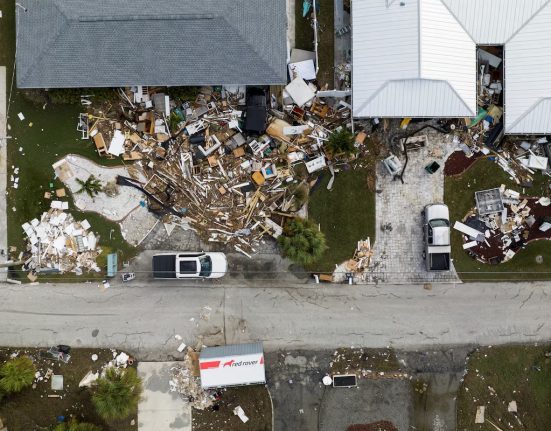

{"left": 295, "top": 0, "right": 335, "bottom": 89}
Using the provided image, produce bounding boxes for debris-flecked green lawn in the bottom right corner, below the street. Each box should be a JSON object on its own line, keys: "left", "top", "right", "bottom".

{"left": 457, "top": 345, "right": 551, "bottom": 431}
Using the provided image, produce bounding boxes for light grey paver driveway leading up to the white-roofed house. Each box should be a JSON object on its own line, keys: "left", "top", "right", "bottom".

{"left": 371, "top": 129, "right": 459, "bottom": 284}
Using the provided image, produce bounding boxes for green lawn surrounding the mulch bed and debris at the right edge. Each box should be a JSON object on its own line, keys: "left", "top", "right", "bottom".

{"left": 444, "top": 159, "right": 551, "bottom": 281}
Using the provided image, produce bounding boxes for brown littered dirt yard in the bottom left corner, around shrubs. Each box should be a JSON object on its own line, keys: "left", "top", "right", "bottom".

{"left": 0, "top": 347, "right": 138, "bottom": 431}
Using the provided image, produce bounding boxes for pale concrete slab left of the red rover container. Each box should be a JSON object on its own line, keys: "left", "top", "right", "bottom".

{"left": 138, "top": 362, "right": 191, "bottom": 431}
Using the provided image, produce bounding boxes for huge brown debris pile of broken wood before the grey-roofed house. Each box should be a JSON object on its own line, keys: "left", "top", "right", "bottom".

{"left": 84, "top": 82, "right": 356, "bottom": 255}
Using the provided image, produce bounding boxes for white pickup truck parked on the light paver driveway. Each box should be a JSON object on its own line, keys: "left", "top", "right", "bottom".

{"left": 423, "top": 204, "right": 451, "bottom": 271}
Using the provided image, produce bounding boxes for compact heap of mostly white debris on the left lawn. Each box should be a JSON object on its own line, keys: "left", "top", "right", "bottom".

{"left": 21, "top": 209, "right": 101, "bottom": 277}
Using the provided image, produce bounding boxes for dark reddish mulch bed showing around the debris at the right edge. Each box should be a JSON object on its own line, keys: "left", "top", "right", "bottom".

{"left": 465, "top": 198, "right": 551, "bottom": 264}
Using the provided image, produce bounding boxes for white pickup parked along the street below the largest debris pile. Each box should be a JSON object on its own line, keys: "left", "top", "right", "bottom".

{"left": 153, "top": 252, "right": 228, "bottom": 279}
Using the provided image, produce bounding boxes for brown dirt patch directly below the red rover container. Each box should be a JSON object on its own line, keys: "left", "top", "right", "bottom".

{"left": 192, "top": 385, "right": 272, "bottom": 431}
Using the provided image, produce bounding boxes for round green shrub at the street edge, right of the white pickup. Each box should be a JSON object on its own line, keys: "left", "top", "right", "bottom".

{"left": 278, "top": 219, "right": 327, "bottom": 265}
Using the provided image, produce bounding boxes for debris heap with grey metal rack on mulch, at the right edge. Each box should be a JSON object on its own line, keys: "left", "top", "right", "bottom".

{"left": 454, "top": 185, "right": 551, "bottom": 264}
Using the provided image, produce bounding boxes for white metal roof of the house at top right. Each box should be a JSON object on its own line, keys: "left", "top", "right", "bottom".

{"left": 352, "top": 0, "right": 551, "bottom": 134}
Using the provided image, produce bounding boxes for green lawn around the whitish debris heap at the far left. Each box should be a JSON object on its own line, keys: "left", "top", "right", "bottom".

{"left": 0, "top": 0, "right": 136, "bottom": 281}
